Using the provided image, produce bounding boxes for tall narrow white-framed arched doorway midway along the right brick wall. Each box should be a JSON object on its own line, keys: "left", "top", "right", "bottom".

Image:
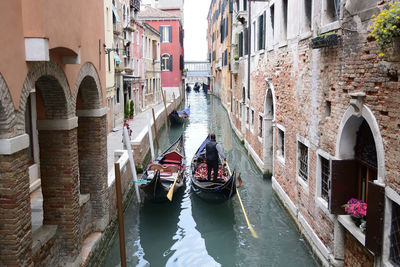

{"left": 263, "top": 80, "right": 275, "bottom": 176}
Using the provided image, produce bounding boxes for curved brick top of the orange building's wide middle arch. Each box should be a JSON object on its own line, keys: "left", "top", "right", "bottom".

{"left": 17, "top": 61, "right": 75, "bottom": 134}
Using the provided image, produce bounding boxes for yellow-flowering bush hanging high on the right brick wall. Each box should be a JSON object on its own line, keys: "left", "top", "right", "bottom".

{"left": 369, "top": 2, "right": 400, "bottom": 57}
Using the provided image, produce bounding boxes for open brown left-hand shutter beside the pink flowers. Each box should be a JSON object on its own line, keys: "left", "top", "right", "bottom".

{"left": 329, "top": 160, "right": 358, "bottom": 214}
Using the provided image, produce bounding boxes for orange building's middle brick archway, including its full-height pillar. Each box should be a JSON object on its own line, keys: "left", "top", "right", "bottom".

{"left": 17, "top": 61, "right": 81, "bottom": 261}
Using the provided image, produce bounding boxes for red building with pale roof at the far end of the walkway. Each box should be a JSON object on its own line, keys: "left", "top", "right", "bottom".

{"left": 138, "top": 5, "right": 184, "bottom": 102}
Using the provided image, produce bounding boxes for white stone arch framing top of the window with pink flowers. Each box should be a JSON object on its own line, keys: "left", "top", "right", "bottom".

{"left": 335, "top": 105, "right": 385, "bottom": 183}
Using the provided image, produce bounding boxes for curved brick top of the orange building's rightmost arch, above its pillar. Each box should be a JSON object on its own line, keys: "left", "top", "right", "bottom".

{"left": 72, "top": 62, "right": 103, "bottom": 109}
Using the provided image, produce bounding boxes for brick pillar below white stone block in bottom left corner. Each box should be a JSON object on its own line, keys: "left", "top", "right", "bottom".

{"left": 0, "top": 149, "right": 32, "bottom": 266}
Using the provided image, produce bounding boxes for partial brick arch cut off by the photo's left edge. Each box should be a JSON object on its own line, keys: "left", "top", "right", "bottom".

{"left": 0, "top": 73, "right": 15, "bottom": 138}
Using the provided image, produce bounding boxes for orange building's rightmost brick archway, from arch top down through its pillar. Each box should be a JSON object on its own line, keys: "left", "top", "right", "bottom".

{"left": 74, "top": 63, "right": 108, "bottom": 232}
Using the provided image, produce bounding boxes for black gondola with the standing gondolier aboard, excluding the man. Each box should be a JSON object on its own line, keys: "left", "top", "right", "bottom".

{"left": 190, "top": 138, "right": 236, "bottom": 203}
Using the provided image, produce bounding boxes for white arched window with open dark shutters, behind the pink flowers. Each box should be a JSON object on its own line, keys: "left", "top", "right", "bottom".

{"left": 329, "top": 104, "right": 385, "bottom": 264}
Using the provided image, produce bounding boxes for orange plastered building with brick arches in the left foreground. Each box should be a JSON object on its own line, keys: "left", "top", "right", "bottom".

{"left": 0, "top": 0, "right": 108, "bottom": 266}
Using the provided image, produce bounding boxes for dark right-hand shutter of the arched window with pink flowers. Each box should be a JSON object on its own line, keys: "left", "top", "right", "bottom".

{"left": 365, "top": 182, "right": 385, "bottom": 255}
